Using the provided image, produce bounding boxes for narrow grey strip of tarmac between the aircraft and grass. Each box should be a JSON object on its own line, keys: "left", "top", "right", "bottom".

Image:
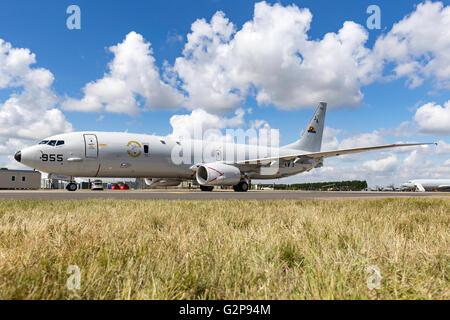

{"left": 0, "top": 190, "right": 450, "bottom": 200}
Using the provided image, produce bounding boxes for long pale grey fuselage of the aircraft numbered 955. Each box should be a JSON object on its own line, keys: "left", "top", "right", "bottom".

{"left": 20, "top": 132, "right": 317, "bottom": 179}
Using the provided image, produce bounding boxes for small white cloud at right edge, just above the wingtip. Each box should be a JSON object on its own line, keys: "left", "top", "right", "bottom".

{"left": 414, "top": 100, "right": 450, "bottom": 135}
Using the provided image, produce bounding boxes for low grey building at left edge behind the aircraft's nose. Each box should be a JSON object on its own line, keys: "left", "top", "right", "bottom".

{"left": 0, "top": 169, "right": 41, "bottom": 189}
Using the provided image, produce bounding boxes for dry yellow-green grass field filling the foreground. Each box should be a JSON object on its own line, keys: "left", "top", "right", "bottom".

{"left": 0, "top": 199, "right": 450, "bottom": 299}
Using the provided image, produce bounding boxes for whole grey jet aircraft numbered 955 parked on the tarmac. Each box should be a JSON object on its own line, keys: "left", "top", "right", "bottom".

{"left": 14, "top": 102, "right": 436, "bottom": 192}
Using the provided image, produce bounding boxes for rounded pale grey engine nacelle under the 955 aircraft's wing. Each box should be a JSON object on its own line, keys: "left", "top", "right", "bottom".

{"left": 196, "top": 162, "right": 241, "bottom": 186}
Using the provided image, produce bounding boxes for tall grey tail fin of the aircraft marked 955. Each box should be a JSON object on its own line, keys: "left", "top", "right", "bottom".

{"left": 283, "top": 102, "right": 327, "bottom": 152}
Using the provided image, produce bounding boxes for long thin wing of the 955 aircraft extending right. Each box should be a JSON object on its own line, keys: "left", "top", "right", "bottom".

{"left": 237, "top": 142, "right": 436, "bottom": 165}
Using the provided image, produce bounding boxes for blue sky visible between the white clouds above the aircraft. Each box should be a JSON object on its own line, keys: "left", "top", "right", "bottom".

{"left": 0, "top": 0, "right": 450, "bottom": 185}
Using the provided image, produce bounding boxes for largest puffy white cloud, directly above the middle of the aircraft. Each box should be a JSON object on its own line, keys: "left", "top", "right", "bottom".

{"left": 174, "top": 2, "right": 370, "bottom": 112}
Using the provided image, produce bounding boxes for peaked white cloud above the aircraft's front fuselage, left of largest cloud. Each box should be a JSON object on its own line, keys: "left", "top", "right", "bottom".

{"left": 62, "top": 31, "right": 184, "bottom": 114}
